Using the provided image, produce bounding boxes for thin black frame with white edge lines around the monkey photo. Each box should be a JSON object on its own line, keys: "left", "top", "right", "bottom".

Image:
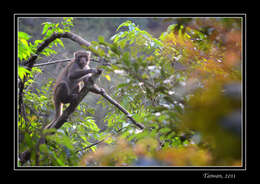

{"left": 9, "top": 10, "right": 247, "bottom": 178}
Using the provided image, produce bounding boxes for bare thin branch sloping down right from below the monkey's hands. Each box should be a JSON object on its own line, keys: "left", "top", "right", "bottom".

{"left": 90, "top": 85, "right": 144, "bottom": 129}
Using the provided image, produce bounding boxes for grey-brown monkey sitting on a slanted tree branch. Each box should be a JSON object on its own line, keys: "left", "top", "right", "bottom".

{"left": 45, "top": 51, "right": 100, "bottom": 129}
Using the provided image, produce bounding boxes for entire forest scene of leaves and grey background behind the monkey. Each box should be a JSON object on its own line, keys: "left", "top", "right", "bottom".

{"left": 17, "top": 17, "right": 243, "bottom": 166}
